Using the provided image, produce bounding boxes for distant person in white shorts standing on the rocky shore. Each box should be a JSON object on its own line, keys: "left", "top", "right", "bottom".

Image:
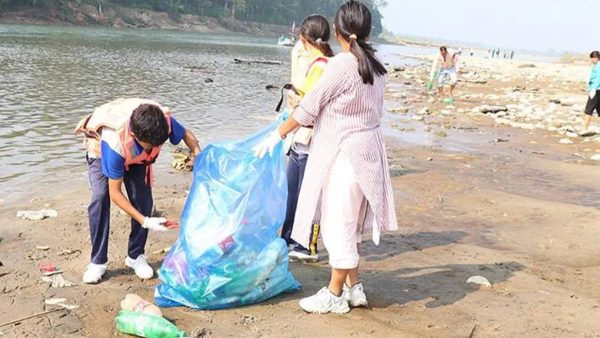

{"left": 429, "top": 46, "right": 458, "bottom": 100}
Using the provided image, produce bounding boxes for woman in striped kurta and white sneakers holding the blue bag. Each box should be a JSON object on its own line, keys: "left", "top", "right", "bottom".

{"left": 256, "top": 1, "right": 398, "bottom": 313}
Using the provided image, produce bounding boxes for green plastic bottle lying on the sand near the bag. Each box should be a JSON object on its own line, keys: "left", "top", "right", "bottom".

{"left": 115, "top": 311, "right": 185, "bottom": 338}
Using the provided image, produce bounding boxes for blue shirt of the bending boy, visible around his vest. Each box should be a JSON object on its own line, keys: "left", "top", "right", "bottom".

{"left": 100, "top": 117, "right": 185, "bottom": 180}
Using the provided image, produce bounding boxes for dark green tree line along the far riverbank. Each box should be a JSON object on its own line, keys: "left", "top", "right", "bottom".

{"left": 0, "top": 0, "right": 385, "bottom": 35}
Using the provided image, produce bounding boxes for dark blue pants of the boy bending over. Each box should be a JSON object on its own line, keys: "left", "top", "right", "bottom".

{"left": 87, "top": 158, "right": 153, "bottom": 264}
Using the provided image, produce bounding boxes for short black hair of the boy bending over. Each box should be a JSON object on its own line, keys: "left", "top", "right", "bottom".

{"left": 130, "top": 103, "right": 169, "bottom": 147}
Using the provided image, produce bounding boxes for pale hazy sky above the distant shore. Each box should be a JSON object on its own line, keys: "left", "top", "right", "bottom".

{"left": 383, "top": 0, "right": 600, "bottom": 52}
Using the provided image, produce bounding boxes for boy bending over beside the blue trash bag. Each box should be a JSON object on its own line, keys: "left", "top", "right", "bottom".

{"left": 75, "top": 99, "right": 200, "bottom": 284}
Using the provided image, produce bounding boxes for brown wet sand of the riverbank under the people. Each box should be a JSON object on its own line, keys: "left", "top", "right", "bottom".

{"left": 0, "top": 54, "right": 600, "bottom": 337}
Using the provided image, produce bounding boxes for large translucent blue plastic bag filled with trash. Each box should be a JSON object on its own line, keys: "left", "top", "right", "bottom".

{"left": 154, "top": 123, "right": 300, "bottom": 309}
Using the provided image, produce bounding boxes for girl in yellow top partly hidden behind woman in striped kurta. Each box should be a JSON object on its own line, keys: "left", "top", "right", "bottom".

{"left": 281, "top": 15, "right": 333, "bottom": 261}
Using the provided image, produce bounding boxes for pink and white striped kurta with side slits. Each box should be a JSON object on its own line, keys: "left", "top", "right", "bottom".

{"left": 292, "top": 53, "right": 398, "bottom": 247}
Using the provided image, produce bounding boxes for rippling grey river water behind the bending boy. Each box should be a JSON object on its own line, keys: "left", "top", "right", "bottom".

{"left": 0, "top": 24, "right": 432, "bottom": 203}
